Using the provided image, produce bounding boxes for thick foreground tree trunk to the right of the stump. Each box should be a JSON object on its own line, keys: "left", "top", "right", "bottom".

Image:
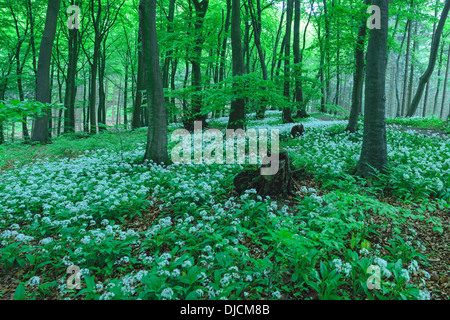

{"left": 357, "top": 0, "right": 389, "bottom": 177}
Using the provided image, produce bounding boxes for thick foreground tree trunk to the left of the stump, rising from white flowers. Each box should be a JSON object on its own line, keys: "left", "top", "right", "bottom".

{"left": 140, "top": 0, "right": 169, "bottom": 164}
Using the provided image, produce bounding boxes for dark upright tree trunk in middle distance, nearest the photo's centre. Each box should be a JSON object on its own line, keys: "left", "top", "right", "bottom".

{"left": 227, "top": 0, "right": 245, "bottom": 129}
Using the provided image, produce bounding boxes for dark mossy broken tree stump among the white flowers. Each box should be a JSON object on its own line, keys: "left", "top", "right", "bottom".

{"left": 233, "top": 152, "right": 305, "bottom": 196}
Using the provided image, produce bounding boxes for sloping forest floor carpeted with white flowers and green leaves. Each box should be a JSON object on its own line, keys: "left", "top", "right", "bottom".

{"left": 0, "top": 111, "right": 450, "bottom": 300}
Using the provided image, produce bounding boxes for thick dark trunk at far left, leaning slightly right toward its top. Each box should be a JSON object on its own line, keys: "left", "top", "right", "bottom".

{"left": 31, "top": 0, "right": 61, "bottom": 143}
